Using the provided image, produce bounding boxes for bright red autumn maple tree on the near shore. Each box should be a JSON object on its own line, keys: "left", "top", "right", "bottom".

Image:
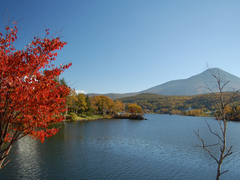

{"left": 0, "top": 22, "right": 71, "bottom": 168}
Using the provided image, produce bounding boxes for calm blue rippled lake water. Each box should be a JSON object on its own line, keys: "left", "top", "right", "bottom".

{"left": 0, "top": 114, "right": 240, "bottom": 180}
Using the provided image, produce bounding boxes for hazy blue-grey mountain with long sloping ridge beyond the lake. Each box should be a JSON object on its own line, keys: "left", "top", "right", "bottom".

{"left": 87, "top": 68, "right": 240, "bottom": 99}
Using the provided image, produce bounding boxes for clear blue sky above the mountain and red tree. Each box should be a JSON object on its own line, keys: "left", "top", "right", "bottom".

{"left": 0, "top": 0, "right": 240, "bottom": 94}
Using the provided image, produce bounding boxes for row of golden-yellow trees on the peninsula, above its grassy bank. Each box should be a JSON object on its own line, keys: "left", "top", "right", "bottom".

{"left": 66, "top": 90, "right": 143, "bottom": 116}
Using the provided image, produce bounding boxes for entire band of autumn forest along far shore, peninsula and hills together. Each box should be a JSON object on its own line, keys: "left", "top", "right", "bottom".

{"left": 66, "top": 90, "right": 240, "bottom": 122}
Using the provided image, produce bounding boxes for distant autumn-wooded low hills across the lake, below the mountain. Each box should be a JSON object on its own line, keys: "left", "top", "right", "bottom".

{"left": 118, "top": 92, "right": 240, "bottom": 116}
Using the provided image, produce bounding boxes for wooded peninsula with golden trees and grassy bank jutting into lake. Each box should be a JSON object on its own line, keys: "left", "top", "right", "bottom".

{"left": 65, "top": 94, "right": 146, "bottom": 122}
